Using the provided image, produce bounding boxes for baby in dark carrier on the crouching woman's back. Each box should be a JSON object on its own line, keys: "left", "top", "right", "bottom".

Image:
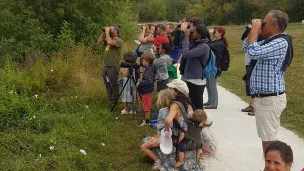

{"left": 174, "top": 109, "right": 207, "bottom": 168}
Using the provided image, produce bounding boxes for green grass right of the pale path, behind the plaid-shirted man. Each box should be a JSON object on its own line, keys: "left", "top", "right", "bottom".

{"left": 219, "top": 23, "right": 304, "bottom": 137}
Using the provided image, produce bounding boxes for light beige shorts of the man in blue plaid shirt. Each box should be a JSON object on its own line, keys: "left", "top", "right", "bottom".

{"left": 253, "top": 93, "right": 287, "bottom": 141}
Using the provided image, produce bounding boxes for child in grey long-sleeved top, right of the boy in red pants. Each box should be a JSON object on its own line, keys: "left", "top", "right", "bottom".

{"left": 153, "top": 43, "right": 173, "bottom": 92}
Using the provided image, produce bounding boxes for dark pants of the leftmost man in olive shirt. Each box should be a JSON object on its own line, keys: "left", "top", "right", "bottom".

{"left": 102, "top": 66, "right": 119, "bottom": 103}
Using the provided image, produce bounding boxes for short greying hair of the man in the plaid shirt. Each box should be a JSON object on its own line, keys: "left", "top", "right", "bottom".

{"left": 269, "top": 10, "right": 289, "bottom": 33}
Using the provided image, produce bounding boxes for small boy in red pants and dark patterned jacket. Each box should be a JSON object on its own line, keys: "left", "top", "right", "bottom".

{"left": 137, "top": 52, "right": 155, "bottom": 126}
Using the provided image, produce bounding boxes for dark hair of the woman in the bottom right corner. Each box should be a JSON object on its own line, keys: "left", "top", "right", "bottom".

{"left": 264, "top": 141, "right": 293, "bottom": 164}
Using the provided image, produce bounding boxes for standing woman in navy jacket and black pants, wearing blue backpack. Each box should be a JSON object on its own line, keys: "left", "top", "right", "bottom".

{"left": 182, "top": 24, "right": 210, "bottom": 109}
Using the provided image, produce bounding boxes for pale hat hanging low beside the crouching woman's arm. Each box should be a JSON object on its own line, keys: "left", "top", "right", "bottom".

{"left": 159, "top": 128, "right": 173, "bottom": 154}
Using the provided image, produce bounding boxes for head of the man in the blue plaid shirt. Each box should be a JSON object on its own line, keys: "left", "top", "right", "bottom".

{"left": 261, "top": 10, "right": 289, "bottom": 38}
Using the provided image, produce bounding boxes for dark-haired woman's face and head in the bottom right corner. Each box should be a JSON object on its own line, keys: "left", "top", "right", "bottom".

{"left": 264, "top": 141, "right": 293, "bottom": 171}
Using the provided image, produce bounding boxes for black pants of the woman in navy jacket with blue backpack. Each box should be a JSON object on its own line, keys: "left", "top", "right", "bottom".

{"left": 187, "top": 81, "right": 205, "bottom": 109}
